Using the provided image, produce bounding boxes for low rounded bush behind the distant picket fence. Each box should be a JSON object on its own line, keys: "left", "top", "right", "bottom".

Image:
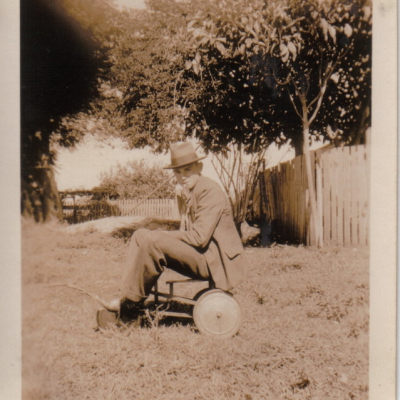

{"left": 93, "top": 160, "right": 175, "bottom": 199}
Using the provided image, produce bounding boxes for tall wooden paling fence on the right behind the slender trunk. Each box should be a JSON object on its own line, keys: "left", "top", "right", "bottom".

{"left": 264, "top": 145, "right": 370, "bottom": 246}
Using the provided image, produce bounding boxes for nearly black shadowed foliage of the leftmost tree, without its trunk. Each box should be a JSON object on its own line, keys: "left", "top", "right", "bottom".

{"left": 21, "top": 0, "right": 113, "bottom": 161}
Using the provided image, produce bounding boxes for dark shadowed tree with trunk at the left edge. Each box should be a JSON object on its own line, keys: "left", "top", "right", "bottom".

{"left": 21, "top": 0, "right": 117, "bottom": 221}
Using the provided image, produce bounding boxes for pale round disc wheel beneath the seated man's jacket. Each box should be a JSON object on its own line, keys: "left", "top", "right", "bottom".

{"left": 193, "top": 289, "right": 243, "bottom": 338}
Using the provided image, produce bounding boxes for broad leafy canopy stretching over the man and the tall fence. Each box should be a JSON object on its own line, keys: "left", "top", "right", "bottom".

{"left": 80, "top": 0, "right": 371, "bottom": 159}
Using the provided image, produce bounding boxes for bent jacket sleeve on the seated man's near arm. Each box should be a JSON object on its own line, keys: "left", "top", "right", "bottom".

{"left": 171, "top": 186, "right": 225, "bottom": 248}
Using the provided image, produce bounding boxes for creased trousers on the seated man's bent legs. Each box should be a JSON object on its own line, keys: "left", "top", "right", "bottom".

{"left": 121, "top": 229, "right": 210, "bottom": 302}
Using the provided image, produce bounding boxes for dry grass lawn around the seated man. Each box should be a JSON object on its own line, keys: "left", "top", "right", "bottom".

{"left": 22, "top": 222, "right": 369, "bottom": 400}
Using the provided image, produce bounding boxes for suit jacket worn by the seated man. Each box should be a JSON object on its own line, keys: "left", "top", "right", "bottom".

{"left": 170, "top": 176, "right": 246, "bottom": 290}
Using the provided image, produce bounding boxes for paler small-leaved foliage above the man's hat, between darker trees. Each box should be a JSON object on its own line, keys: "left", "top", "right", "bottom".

{"left": 85, "top": 0, "right": 198, "bottom": 151}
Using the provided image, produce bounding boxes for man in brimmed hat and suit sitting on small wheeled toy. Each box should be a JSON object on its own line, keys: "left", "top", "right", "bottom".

{"left": 98, "top": 143, "right": 245, "bottom": 325}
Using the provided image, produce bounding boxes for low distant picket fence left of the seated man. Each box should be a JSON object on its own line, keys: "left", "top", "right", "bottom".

{"left": 63, "top": 197, "right": 179, "bottom": 224}
